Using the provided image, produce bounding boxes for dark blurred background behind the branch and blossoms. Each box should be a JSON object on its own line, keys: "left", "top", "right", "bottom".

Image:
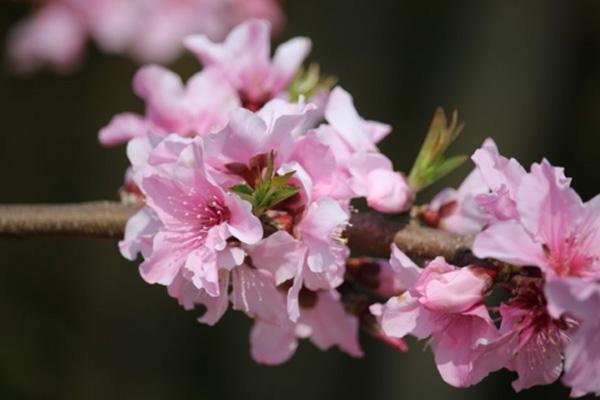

{"left": 0, "top": 0, "right": 600, "bottom": 400}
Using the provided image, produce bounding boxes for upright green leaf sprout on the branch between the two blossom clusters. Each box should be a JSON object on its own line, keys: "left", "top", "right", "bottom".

{"left": 408, "top": 107, "right": 467, "bottom": 192}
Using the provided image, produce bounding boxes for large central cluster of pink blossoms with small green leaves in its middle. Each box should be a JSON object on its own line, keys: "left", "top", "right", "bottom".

{"left": 99, "top": 20, "right": 414, "bottom": 364}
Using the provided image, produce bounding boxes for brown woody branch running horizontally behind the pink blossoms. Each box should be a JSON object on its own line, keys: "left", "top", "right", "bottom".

{"left": 0, "top": 201, "right": 472, "bottom": 264}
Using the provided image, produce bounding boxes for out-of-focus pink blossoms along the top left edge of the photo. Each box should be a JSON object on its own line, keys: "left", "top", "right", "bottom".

{"left": 8, "top": 0, "right": 283, "bottom": 73}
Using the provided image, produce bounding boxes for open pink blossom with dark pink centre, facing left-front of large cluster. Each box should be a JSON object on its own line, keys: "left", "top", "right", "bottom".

{"left": 131, "top": 144, "right": 262, "bottom": 296}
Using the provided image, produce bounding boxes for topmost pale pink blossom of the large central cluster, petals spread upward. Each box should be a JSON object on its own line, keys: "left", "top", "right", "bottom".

{"left": 185, "top": 20, "right": 311, "bottom": 111}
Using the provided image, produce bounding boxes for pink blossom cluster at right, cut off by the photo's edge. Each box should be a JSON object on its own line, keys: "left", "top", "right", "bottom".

{"left": 371, "top": 140, "right": 600, "bottom": 397}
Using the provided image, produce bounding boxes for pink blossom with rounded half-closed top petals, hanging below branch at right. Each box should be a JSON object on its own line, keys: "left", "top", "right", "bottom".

{"left": 371, "top": 249, "right": 502, "bottom": 387}
